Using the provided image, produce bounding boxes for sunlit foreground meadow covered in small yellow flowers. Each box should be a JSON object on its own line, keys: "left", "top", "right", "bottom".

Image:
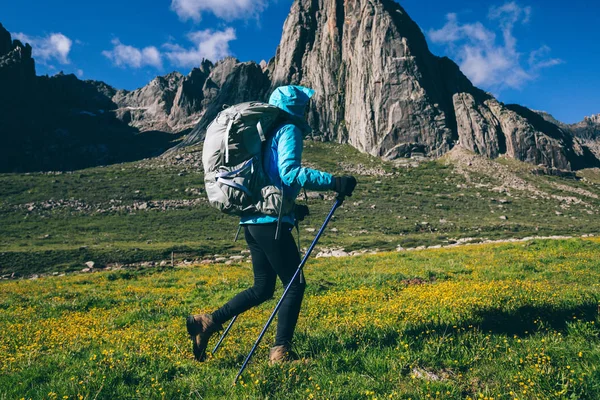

{"left": 0, "top": 239, "right": 600, "bottom": 400}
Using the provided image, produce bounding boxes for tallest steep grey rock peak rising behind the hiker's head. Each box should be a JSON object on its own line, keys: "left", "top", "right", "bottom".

{"left": 273, "top": 0, "right": 453, "bottom": 158}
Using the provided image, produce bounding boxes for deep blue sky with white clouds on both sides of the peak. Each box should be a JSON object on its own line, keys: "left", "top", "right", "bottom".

{"left": 0, "top": 0, "right": 600, "bottom": 123}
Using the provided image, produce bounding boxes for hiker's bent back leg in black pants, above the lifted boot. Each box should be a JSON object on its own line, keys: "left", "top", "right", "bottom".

{"left": 212, "top": 225, "right": 277, "bottom": 324}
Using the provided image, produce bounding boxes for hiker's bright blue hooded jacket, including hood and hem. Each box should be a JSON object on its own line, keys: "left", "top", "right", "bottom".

{"left": 241, "top": 86, "right": 333, "bottom": 225}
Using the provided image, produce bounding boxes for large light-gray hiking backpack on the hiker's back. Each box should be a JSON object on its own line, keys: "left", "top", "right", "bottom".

{"left": 202, "top": 102, "right": 295, "bottom": 216}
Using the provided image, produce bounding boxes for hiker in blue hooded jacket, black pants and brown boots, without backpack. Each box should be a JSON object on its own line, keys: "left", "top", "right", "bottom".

{"left": 187, "top": 86, "right": 356, "bottom": 363}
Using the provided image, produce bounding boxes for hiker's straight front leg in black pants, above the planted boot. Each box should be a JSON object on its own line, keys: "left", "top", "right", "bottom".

{"left": 247, "top": 224, "right": 306, "bottom": 347}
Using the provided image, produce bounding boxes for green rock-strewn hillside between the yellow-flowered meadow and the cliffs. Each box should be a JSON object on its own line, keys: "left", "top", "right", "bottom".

{"left": 0, "top": 142, "right": 600, "bottom": 276}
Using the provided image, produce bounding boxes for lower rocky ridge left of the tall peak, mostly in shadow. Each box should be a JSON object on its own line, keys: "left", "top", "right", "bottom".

{"left": 0, "top": 20, "right": 270, "bottom": 172}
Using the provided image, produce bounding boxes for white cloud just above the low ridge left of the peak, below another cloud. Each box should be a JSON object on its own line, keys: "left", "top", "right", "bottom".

{"left": 163, "top": 28, "right": 236, "bottom": 67}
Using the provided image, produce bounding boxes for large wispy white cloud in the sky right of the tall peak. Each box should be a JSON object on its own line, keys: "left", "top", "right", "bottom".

{"left": 428, "top": 1, "right": 562, "bottom": 91}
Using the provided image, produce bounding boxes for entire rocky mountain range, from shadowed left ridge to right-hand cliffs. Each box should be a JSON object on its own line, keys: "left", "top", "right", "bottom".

{"left": 0, "top": 0, "right": 600, "bottom": 170}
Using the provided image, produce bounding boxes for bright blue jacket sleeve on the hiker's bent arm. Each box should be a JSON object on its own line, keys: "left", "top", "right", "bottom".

{"left": 277, "top": 125, "right": 333, "bottom": 190}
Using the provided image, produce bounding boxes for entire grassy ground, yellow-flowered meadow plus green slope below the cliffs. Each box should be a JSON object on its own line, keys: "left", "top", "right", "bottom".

{"left": 0, "top": 141, "right": 600, "bottom": 400}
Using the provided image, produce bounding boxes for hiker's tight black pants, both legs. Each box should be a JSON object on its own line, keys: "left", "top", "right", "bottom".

{"left": 212, "top": 224, "right": 306, "bottom": 346}
